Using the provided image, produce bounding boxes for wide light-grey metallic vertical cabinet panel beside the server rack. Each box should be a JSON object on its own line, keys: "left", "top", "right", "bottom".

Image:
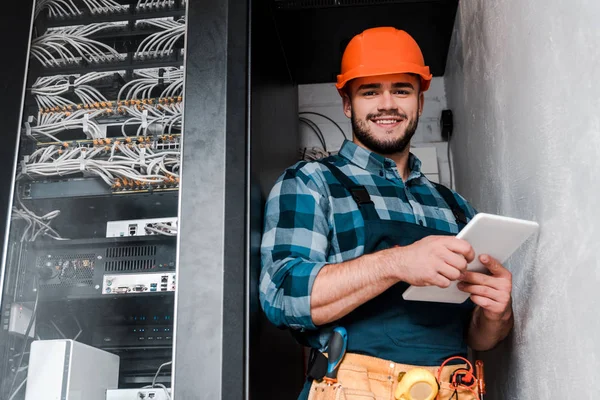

{"left": 174, "top": 0, "right": 227, "bottom": 399}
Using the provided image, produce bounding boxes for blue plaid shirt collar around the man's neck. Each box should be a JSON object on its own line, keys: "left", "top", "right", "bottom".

{"left": 338, "top": 140, "right": 423, "bottom": 182}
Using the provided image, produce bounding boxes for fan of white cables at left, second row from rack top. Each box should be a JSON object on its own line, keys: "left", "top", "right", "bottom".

{"left": 31, "top": 23, "right": 124, "bottom": 67}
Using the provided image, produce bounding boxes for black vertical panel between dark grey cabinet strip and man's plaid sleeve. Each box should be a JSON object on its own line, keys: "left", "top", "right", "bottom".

{"left": 250, "top": 0, "right": 304, "bottom": 399}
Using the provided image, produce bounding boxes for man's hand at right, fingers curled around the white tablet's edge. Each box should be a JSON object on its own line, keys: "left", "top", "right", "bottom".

{"left": 458, "top": 255, "right": 512, "bottom": 321}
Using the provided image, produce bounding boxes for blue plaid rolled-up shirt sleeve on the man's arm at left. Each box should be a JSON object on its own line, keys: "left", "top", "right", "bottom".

{"left": 260, "top": 163, "right": 330, "bottom": 330}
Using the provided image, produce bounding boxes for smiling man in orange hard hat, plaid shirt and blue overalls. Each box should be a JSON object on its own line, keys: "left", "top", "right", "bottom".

{"left": 260, "top": 28, "right": 513, "bottom": 400}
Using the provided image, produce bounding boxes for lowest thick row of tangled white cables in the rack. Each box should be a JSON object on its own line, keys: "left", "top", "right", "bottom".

{"left": 21, "top": 141, "right": 181, "bottom": 188}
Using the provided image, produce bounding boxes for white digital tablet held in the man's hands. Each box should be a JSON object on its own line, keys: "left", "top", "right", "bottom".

{"left": 402, "top": 213, "right": 539, "bottom": 304}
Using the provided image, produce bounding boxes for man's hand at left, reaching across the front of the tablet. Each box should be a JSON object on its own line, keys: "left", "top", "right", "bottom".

{"left": 386, "top": 236, "right": 475, "bottom": 288}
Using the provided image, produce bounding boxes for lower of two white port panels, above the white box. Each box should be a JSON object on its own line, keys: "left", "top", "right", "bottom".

{"left": 102, "top": 272, "right": 176, "bottom": 295}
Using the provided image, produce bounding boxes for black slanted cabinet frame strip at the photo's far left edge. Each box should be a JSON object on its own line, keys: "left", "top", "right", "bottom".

{"left": 0, "top": 0, "right": 33, "bottom": 300}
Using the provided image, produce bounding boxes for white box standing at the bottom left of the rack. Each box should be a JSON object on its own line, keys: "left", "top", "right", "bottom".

{"left": 25, "top": 340, "right": 119, "bottom": 400}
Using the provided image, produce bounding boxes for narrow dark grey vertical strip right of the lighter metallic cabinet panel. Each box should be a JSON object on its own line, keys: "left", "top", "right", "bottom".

{"left": 221, "top": 0, "right": 249, "bottom": 400}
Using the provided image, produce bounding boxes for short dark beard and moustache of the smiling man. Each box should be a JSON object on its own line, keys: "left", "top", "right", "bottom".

{"left": 351, "top": 111, "right": 419, "bottom": 155}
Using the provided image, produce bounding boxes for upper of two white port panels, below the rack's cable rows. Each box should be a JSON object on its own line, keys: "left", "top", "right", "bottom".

{"left": 106, "top": 217, "right": 177, "bottom": 238}
